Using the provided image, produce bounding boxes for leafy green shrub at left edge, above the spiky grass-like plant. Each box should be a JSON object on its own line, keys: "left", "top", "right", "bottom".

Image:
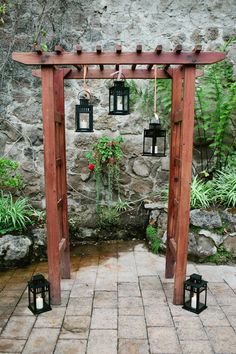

{"left": 0, "top": 158, "right": 23, "bottom": 190}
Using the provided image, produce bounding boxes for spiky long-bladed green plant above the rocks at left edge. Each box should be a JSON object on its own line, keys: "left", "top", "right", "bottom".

{"left": 0, "top": 193, "right": 34, "bottom": 235}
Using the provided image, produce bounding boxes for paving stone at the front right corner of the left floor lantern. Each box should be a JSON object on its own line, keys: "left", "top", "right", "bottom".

{"left": 34, "top": 307, "right": 66, "bottom": 328}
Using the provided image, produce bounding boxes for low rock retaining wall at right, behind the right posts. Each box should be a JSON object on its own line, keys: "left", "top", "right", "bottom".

{"left": 144, "top": 202, "right": 236, "bottom": 261}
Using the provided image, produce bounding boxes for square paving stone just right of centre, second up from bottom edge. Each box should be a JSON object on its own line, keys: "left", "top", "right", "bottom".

{"left": 118, "top": 316, "right": 147, "bottom": 339}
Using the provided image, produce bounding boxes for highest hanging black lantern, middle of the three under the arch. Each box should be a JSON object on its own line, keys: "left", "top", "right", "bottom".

{"left": 109, "top": 80, "right": 129, "bottom": 115}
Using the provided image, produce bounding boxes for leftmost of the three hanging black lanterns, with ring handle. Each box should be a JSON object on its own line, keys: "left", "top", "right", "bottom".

{"left": 75, "top": 91, "right": 93, "bottom": 133}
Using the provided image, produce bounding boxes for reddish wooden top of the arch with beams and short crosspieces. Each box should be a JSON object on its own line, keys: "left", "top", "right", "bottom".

{"left": 12, "top": 44, "right": 225, "bottom": 79}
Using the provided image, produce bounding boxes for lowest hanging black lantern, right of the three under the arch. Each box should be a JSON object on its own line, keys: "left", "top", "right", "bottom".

{"left": 143, "top": 123, "right": 166, "bottom": 157}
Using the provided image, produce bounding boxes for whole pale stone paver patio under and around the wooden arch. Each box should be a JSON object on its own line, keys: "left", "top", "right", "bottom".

{"left": 0, "top": 242, "right": 236, "bottom": 354}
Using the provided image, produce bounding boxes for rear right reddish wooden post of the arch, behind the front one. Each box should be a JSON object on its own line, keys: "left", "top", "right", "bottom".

{"left": 165, "top": 69, "right": 182, "bottom": 278}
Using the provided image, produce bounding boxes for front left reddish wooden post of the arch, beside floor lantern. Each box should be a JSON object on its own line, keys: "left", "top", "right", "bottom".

{"left": 41, "top": 66, "right": 61, "bottom": 305}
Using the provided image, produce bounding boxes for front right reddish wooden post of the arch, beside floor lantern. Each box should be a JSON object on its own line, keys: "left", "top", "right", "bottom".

{"left": 173, "top": 66, "right": 195, "bottom": 305}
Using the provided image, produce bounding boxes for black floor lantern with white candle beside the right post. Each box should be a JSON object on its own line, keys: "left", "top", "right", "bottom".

{"left": 183, "top": 274, "right": 207, "bottom": 313}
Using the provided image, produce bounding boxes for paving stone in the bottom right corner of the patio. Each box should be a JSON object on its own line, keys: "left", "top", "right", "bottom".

{"left": 205, "top": 327, "right": 236, "bottom": 354}
